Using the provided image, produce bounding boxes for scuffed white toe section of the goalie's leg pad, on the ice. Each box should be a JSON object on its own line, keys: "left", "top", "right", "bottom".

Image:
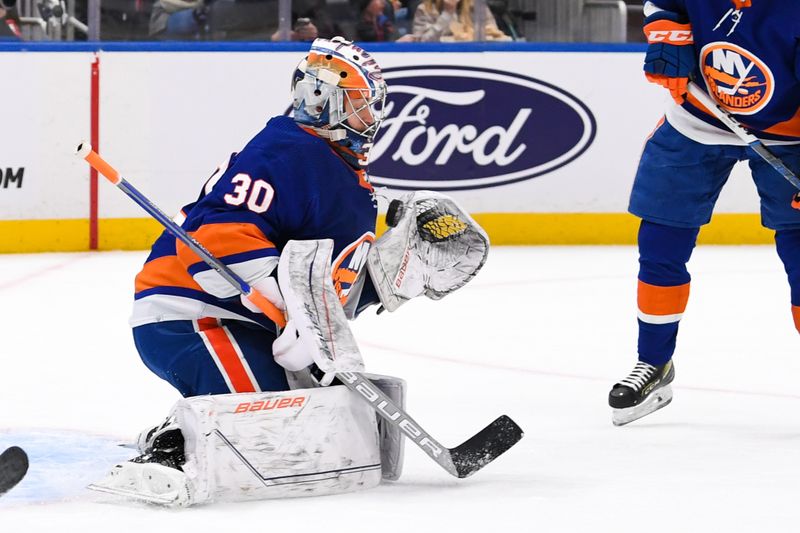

{"left": 87, "top": 462, "right": 192, "bottom": 507}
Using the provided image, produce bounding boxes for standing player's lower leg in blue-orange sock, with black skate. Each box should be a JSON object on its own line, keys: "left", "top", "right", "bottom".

{"left": 608, "top": 221, "right": 698, "bottom": 426}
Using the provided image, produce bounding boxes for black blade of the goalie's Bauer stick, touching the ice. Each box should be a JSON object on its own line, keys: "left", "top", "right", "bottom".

{"left": 450, "top": 415, "right": 524, "bottom": 478}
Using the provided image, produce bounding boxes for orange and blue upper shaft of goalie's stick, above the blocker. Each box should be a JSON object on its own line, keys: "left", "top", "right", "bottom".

{"left": 76, "top": 142, "right": 286, "bottom": 327}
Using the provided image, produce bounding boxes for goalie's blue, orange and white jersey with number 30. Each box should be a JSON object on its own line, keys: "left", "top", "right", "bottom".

{"left": 131, "top": 117, "right": 377, "bottom": 329}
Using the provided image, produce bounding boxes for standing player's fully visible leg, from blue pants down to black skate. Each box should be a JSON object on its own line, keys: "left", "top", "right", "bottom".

{"left": 620, "top": 120, "right": 744, "bottom": 425}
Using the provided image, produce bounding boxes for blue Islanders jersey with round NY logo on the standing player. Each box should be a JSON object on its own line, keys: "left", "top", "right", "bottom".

{"left": 649, "top": 0, "right": 800, "bottom": 141}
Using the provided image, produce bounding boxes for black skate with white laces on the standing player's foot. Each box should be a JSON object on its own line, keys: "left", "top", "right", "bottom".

{"left": 608, "top": 360, "right": 675, "bottom": 426}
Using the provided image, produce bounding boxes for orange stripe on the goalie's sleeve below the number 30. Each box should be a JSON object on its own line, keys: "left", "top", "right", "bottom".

{"left": 177, "top": 222, "right": 275, "bottom": 268}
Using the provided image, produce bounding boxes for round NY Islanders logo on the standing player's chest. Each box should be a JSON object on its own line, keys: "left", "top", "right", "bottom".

{"left": 700, "top": 42, "right": 775, "bottom": 115}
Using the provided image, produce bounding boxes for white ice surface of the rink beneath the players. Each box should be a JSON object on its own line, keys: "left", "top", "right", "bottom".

{"left": 0, "top": 247, "right": 800, "bottom": 533}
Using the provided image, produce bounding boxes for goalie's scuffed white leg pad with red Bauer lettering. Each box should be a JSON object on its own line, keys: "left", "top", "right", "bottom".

{"left": 90, "top": 386, "right": 381, "bottom": 506}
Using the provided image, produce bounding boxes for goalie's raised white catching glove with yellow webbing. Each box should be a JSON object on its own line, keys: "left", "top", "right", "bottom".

{"left": 367, "top": 191, "right": 489, "bottom": 311}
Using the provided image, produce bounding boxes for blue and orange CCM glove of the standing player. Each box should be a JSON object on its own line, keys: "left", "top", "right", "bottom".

{"left": 644, "top": 11, "right": 697, "bottom": 105}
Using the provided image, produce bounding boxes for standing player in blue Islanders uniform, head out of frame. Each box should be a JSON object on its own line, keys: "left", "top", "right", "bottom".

{"left": 609, "top": 0, "right": 800, "bottom": 425}
